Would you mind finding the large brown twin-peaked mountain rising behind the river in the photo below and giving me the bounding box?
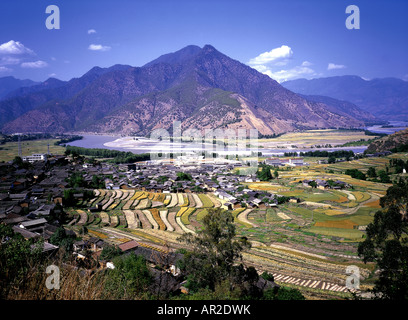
[0,45,363,135]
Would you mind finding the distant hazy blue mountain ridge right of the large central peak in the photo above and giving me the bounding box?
[282,76,408,120]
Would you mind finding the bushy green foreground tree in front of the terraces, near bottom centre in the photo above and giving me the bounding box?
[179,208,253,292]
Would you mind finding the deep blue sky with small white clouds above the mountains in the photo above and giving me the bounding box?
[0,0,408,82]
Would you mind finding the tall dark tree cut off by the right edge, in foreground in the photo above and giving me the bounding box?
[358,180,408,300]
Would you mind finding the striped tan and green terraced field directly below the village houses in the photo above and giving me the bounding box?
[73,189,221,233]
